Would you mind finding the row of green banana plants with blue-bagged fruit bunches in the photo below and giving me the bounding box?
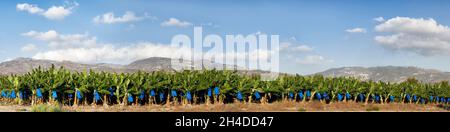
[0,66,450,106]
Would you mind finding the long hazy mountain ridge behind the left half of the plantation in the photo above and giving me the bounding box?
[0,57,245,75]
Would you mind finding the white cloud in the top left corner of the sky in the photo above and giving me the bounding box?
[16,2,79,20]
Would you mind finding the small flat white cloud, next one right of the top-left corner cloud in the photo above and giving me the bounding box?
[93,11,156,24]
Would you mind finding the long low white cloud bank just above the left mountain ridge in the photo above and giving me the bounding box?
[33,42,270,64]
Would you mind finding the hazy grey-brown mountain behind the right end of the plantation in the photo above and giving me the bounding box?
[316,66,450,82]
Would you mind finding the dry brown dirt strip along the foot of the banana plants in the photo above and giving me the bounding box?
[0,102,450,112]
